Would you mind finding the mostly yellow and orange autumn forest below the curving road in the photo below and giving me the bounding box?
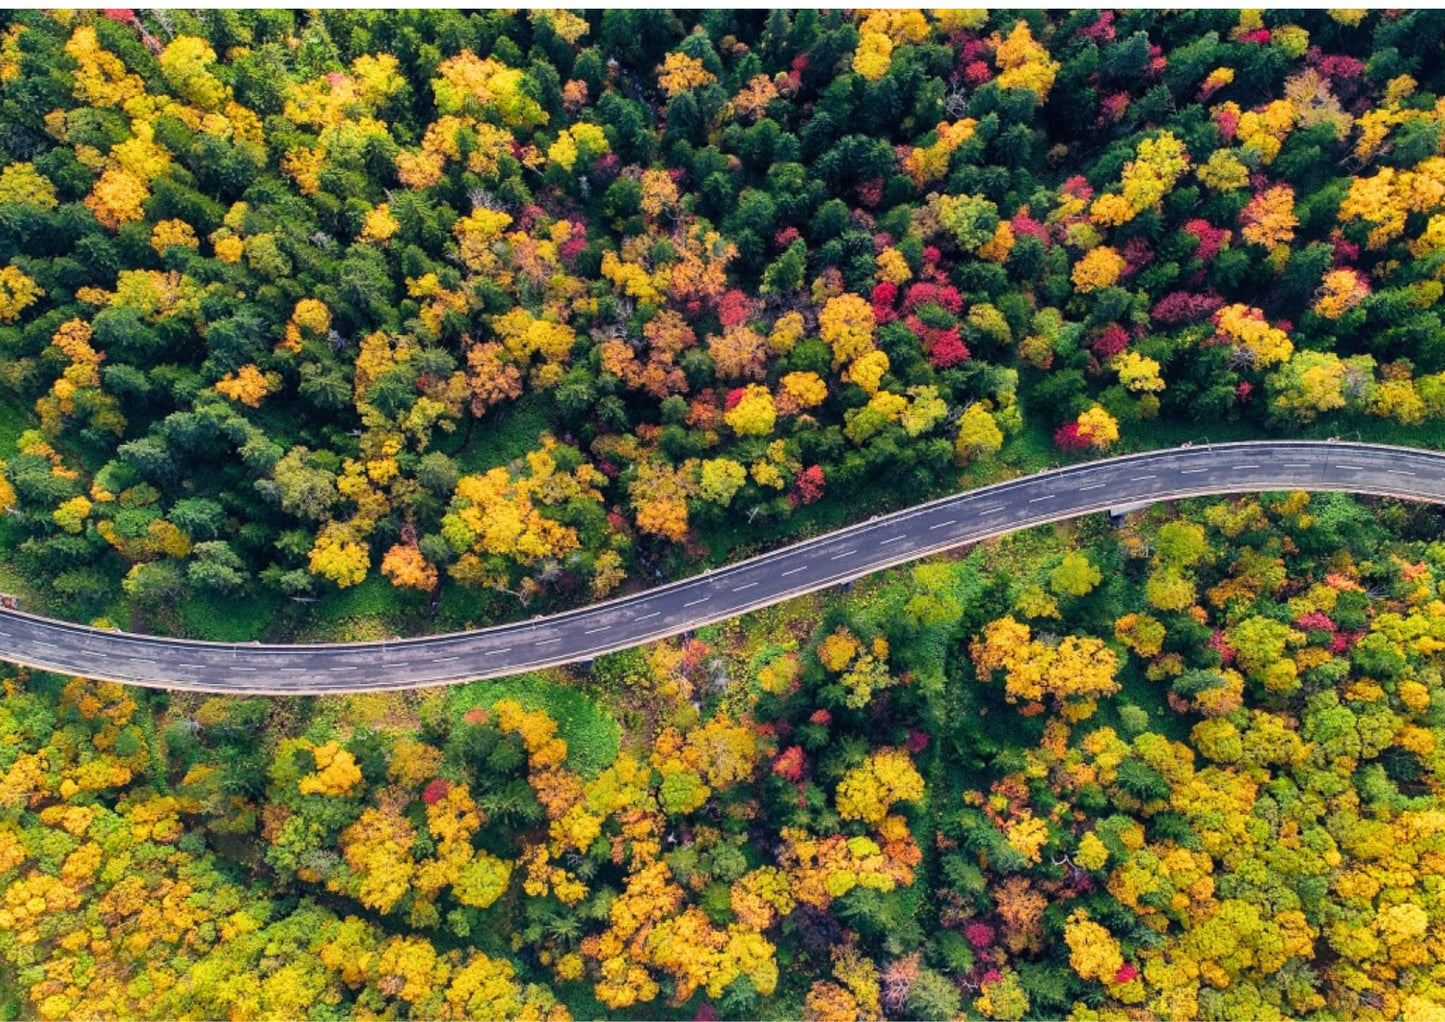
[0,493,1445,1019]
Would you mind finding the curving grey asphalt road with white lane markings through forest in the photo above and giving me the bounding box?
[0,441,1445,695]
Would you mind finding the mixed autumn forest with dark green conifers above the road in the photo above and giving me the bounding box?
[8,10,1445,637]
